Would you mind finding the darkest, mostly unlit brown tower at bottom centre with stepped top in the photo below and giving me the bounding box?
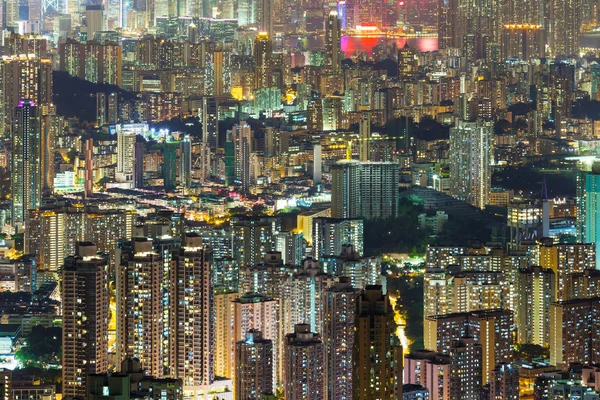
[352,285,403,400]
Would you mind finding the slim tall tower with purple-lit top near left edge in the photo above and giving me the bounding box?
[11,99,43,227]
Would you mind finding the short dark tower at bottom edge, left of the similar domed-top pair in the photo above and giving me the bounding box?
[234,330,274,400]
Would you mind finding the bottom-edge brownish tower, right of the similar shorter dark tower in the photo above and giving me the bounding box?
[283,324,325,400]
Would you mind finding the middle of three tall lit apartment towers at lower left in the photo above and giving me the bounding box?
[116,238,168,378]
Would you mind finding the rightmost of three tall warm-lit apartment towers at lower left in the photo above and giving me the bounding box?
[169,234,215,393]
